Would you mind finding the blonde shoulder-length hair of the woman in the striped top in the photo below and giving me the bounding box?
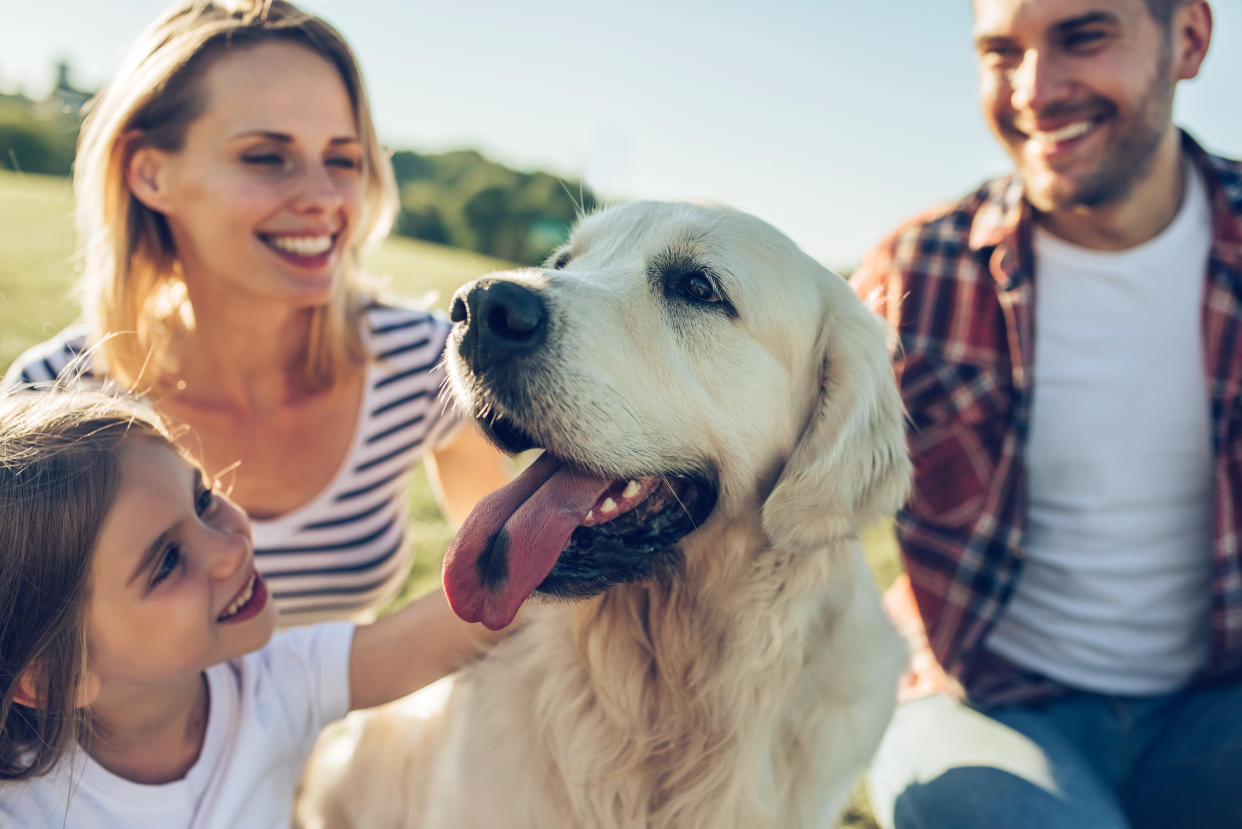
[73,0,396,389]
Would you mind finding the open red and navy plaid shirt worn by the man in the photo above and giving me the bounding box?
[853,135,1242,705]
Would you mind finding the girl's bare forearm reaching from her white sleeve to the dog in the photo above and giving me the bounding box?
[349,590,513,710]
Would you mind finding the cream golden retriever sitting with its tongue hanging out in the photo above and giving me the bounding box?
[299,203,909,829]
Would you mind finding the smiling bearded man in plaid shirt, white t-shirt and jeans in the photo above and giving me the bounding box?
[854,0,1242,829]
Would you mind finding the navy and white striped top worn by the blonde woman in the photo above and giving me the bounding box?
[6,306,460,625]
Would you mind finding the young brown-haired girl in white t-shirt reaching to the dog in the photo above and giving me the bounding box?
[0,393,504,829]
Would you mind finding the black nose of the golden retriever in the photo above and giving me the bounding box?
[448,280,548,372]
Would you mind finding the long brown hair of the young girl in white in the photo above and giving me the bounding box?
[0,392,175,779]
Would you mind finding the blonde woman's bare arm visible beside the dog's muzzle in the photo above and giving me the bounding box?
[426,423,513,527]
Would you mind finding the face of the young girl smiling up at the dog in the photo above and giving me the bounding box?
[87,437,276,689]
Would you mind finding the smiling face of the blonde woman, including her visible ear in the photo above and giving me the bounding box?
[138,41,366,311]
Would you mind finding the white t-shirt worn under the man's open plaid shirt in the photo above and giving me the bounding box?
[986,161,1213,695]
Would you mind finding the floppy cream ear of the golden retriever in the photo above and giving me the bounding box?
[763,285,910,549]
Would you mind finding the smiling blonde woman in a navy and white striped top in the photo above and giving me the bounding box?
[9,0,508,625]
